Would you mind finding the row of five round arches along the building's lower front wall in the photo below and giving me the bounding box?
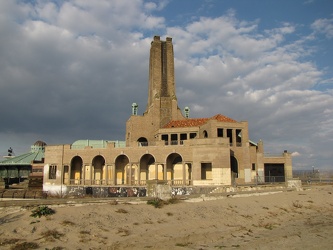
[63,153,192,186]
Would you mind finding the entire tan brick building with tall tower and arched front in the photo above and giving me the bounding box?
[43,36,292,196]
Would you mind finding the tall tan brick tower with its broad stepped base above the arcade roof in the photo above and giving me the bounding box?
[126,36,185,145]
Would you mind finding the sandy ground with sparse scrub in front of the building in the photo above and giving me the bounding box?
[0,185,333,250]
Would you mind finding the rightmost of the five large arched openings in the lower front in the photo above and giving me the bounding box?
[166,153,184,185]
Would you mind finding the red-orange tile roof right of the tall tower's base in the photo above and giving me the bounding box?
[164,114,237,128]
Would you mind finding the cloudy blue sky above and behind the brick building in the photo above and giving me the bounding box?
[0,0,333,169]
